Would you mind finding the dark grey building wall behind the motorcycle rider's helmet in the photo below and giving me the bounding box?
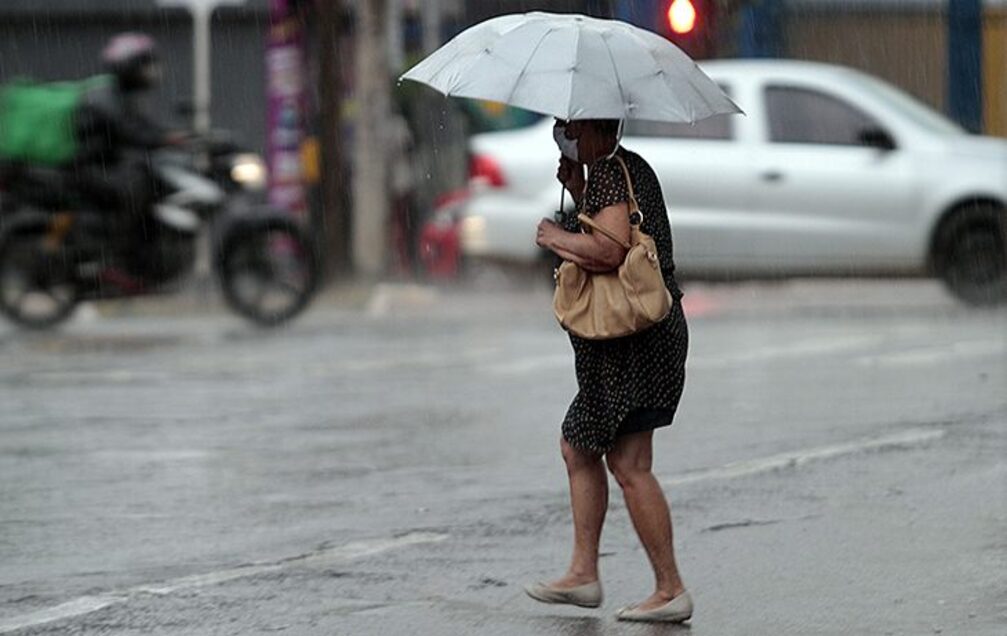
[0,0,268,151]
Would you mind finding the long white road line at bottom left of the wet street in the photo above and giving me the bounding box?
[0,532,448,634]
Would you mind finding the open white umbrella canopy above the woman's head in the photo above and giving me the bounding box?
[401,12,741,123]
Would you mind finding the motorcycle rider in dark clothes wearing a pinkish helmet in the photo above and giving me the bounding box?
[73,33,185,267]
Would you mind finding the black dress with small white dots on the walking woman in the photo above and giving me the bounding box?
[563,147,689,454]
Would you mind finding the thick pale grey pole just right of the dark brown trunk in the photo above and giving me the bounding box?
[352,0,391,278]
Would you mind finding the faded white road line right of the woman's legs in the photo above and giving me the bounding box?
[661,429,947,486]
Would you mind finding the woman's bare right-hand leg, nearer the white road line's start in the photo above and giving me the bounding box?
[605,431,685,610]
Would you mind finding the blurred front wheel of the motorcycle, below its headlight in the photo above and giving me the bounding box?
[219,220,319,327]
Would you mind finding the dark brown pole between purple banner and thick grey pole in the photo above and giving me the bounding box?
[316,0,352,276]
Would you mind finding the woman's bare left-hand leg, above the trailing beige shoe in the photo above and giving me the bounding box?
[549,440,608,590]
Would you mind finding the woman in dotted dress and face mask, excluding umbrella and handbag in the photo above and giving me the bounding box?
[526,119,693,623]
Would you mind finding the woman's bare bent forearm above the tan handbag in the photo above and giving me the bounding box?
[536,203,629,272]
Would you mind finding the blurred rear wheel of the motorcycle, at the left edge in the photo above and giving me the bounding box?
[0,228,80,329]
